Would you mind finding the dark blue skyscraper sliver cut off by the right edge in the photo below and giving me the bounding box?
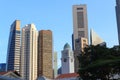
[115,0,120,45]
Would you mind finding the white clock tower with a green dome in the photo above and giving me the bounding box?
[61,43,74,74]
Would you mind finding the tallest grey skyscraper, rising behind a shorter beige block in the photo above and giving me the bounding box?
[73,4,88,50]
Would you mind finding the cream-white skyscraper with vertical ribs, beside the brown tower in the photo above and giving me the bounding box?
[20,24,38,80]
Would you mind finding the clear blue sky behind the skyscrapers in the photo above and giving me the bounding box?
[0,0,118,66]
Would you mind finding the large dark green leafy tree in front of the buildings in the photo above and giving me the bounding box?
[78,45,120,80]
